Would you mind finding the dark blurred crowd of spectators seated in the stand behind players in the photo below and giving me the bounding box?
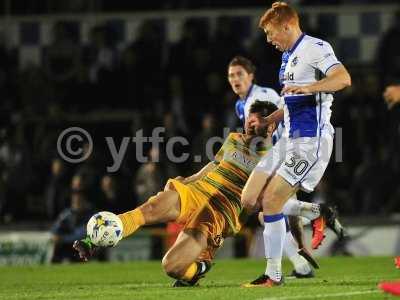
[0,10,400,223]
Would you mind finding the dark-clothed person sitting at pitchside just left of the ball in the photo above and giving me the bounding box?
[51,190,93,263]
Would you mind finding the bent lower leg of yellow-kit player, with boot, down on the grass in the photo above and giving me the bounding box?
[162,229,211,287]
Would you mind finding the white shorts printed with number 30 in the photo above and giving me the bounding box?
[254,126,333,192]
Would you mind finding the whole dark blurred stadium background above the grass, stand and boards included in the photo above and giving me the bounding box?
[0,0,400,262]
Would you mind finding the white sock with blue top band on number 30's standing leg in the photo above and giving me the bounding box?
[263,213,286,281]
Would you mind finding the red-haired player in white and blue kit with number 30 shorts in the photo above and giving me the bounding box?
[242,2,351,287]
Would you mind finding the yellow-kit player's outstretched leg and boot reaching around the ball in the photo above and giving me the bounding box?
[73,190,180,261]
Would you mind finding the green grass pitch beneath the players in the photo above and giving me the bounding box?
[0,257,400,300]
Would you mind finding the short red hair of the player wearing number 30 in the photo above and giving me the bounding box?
[258,2,299,28]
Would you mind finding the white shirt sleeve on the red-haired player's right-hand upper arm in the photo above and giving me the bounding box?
[307,41,341,74]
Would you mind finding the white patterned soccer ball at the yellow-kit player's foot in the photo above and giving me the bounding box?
[86,211,123,247]
